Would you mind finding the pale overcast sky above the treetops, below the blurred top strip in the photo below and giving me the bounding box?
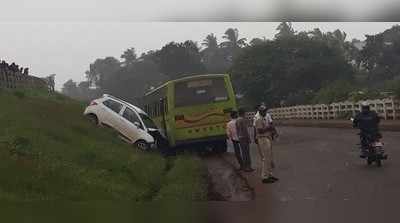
[0,22,395,89]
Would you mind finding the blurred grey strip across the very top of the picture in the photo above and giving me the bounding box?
[0,0,399,22]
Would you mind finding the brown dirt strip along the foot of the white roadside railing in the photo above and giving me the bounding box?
[275,119,400,132]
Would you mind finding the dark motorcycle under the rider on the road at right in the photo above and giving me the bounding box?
[351,119,388,167]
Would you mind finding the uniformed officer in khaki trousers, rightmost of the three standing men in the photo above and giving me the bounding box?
[254,105,279,183]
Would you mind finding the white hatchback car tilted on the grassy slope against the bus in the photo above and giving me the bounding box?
[84,94,158,150]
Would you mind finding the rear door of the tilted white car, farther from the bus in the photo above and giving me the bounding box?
[103,99,123,129]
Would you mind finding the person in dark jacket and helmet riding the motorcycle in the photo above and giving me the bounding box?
[353,102,381,158]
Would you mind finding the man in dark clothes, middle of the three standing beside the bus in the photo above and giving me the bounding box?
[236,109,254,172]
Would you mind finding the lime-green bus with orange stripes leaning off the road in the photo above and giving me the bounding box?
[143,74,237,152]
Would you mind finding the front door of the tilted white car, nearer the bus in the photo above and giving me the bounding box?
[122,107,147,142]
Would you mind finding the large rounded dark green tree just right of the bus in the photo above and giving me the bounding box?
[231,33,354,106]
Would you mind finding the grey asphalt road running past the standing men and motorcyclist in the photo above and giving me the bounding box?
[209,127,400,223]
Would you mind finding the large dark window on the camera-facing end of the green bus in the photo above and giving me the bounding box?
[175,78,229,107]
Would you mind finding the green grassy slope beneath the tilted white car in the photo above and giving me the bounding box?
[0,89,206,201]
